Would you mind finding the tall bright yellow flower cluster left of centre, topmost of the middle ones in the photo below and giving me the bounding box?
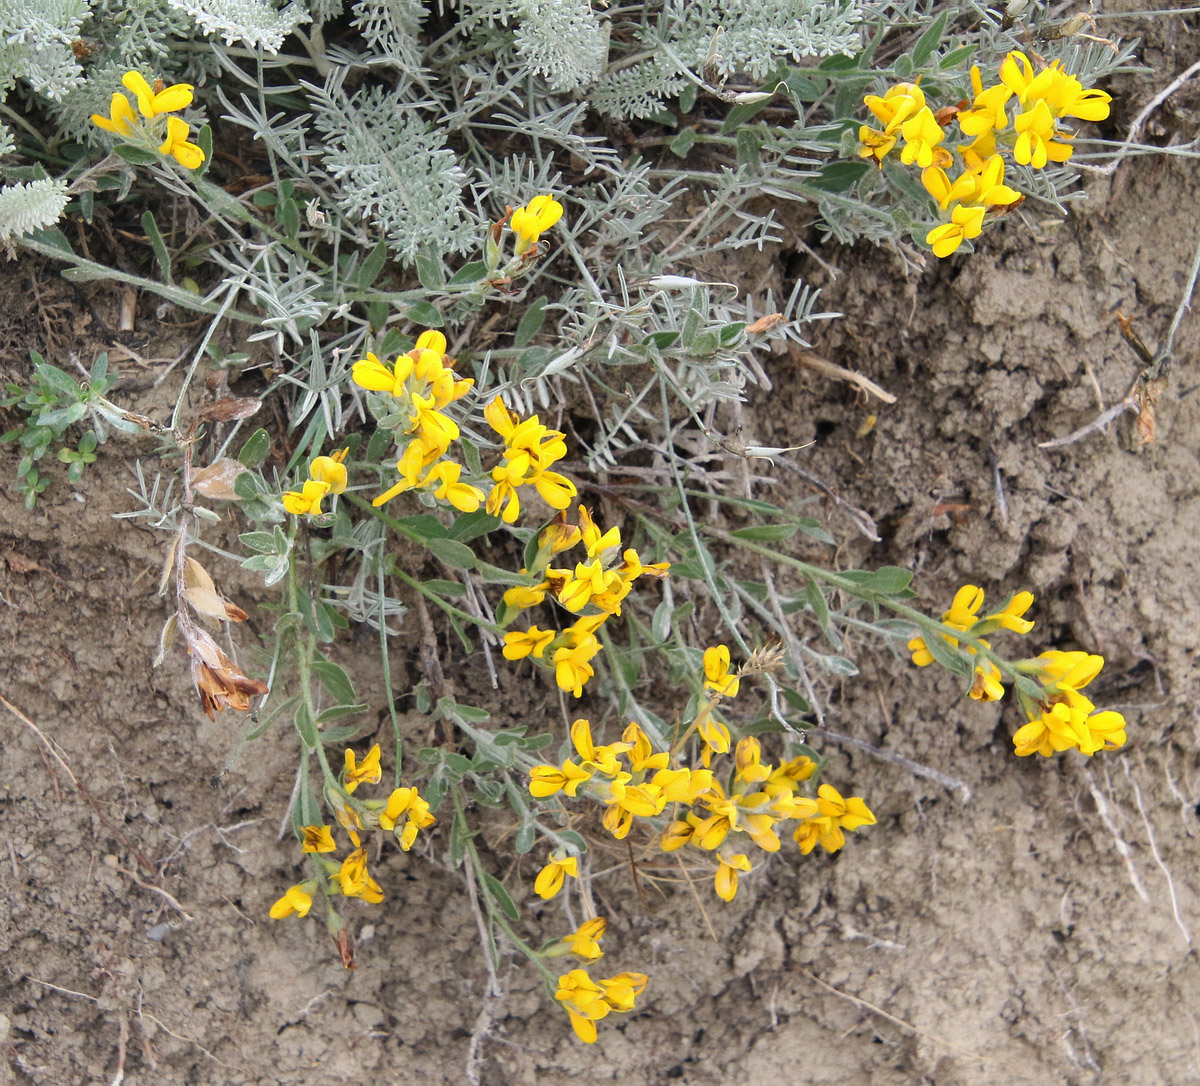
[350,331,484,512]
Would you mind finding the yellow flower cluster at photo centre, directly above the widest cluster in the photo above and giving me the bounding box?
[493,506,670,697]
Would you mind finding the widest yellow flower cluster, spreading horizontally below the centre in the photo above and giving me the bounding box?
[529,686,875,901]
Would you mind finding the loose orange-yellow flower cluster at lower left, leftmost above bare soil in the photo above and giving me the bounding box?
[271,743,437,920]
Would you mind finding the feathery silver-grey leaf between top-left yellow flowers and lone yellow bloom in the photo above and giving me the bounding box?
[305,68,481,263]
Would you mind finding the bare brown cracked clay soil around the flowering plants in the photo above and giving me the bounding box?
[0,16,1200,1086]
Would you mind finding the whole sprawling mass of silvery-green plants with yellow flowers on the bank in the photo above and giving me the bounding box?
[0,0,1161,1042]
